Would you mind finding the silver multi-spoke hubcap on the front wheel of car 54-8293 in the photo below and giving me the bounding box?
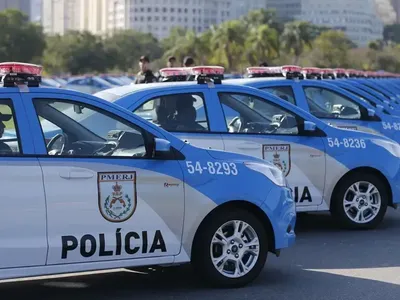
[210,220,260,278]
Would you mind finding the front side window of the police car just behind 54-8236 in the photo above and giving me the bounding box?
[303,86,362,120]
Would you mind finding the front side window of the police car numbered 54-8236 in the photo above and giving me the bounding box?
[218,93,299,135]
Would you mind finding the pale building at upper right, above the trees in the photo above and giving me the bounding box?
[267,0,383,46]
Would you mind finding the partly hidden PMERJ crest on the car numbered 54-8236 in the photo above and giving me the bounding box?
[263,144,291,177]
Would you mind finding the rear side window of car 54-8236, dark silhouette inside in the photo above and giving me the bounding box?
[133,93,209,132]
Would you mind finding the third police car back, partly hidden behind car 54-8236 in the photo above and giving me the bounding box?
[229,66,400,142]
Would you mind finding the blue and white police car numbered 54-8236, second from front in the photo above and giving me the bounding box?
[94,66,400,228]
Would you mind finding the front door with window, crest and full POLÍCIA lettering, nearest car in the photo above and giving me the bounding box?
[23,93,184,265]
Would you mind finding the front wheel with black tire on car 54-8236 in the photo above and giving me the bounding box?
[331,172,389,229]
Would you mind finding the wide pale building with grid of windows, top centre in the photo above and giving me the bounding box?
[108,0,266,39]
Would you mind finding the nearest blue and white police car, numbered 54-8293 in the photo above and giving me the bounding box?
[0,63,296,287]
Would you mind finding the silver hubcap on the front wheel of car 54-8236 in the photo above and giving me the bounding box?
[343,181,381,224]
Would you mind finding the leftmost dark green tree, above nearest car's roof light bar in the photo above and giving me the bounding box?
[0,9,46,62]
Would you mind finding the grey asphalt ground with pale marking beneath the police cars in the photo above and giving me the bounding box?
[0,209,400,300]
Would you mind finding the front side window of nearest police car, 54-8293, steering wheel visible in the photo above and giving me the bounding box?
[34,99,151,158]
